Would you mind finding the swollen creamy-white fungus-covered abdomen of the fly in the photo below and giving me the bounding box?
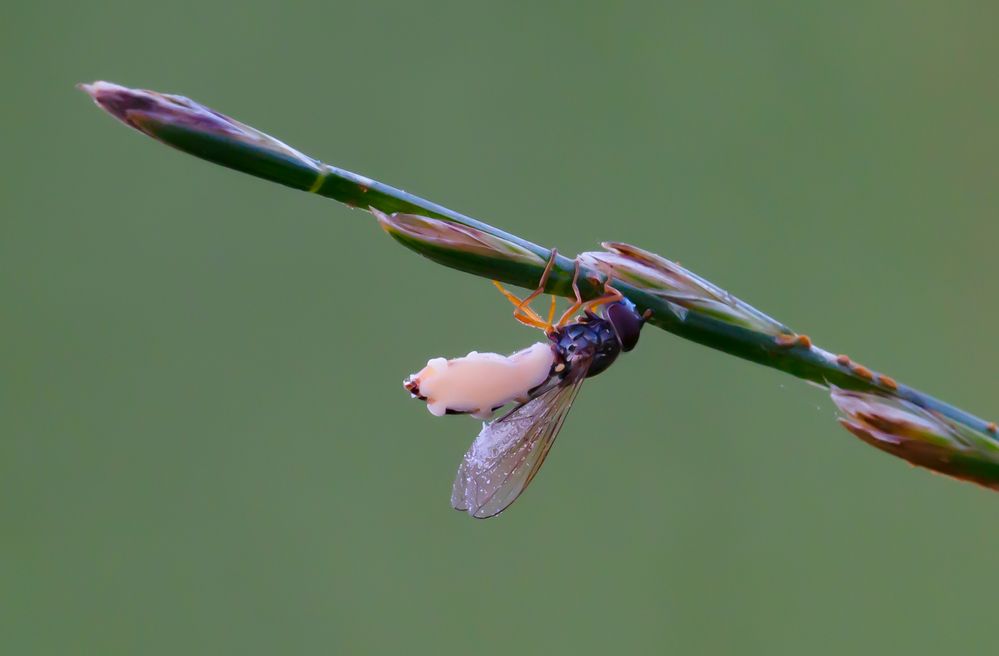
[405,342,555,419]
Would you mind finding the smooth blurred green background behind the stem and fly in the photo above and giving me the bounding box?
[0,0,999,655]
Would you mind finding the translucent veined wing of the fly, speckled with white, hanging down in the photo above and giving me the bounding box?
[451,363,589,519]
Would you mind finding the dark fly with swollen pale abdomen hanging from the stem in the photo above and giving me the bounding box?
[404,250,648,519]
